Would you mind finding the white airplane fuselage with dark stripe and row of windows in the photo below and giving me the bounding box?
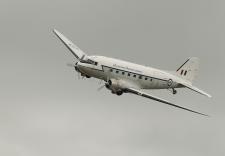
[77,56,180,89]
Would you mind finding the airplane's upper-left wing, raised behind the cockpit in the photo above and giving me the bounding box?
[53,29,86,60]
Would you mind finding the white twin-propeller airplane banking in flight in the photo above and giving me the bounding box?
[53,29,211,116]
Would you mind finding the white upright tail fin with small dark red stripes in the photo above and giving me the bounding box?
[176,57,199,83]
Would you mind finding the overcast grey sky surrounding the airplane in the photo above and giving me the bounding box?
[0,0,225,156]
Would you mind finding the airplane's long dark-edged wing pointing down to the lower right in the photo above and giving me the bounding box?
[125,88,208,116]
